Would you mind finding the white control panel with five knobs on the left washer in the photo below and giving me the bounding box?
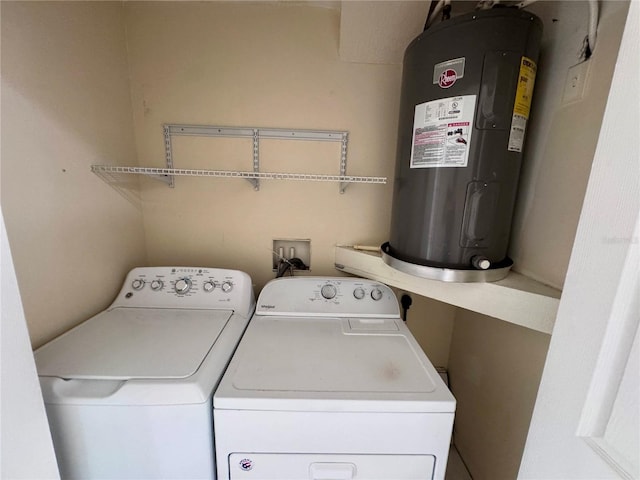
[110,267,254,316]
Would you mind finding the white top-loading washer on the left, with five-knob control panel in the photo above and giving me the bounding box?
[35,267,255,479]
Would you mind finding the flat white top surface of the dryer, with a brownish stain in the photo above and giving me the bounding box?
[229,316,436,398]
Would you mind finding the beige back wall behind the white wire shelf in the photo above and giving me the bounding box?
[125,2,401,290]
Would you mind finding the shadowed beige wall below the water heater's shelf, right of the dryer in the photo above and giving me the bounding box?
[449,309,550,480]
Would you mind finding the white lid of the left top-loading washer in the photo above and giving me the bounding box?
[35,307,233,380]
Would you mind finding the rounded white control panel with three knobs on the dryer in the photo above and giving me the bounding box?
[256,277,400,318]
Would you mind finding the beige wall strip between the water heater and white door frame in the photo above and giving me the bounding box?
[509,0,628,289]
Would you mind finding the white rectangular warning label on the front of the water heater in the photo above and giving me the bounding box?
[410,95,476,168]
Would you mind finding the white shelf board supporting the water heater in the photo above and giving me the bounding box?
[335,247,562,334]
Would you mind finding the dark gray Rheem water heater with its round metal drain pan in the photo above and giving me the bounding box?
[382,8,542,281]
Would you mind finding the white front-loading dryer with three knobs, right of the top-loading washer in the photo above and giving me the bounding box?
[213,277,456,480]
